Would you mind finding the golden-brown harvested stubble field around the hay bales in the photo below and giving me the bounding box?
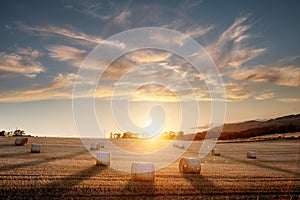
[0,137,300,199]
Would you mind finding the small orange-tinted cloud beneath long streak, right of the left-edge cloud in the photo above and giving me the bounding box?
[46,45,86,67]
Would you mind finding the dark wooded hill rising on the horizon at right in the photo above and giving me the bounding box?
[194,114,300,140]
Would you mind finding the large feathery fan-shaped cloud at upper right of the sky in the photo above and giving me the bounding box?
[207,16,266,69]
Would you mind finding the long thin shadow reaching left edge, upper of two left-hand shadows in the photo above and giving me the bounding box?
[1,150,87,171]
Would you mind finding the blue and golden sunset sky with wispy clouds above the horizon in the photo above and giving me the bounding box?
[0,0,300,137]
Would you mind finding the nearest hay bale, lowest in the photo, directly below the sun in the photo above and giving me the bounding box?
[131,162,155,182]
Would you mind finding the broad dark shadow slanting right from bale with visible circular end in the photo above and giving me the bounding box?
[181,174,224,195]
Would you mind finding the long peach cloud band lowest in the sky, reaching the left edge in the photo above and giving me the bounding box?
[0,73,76,102]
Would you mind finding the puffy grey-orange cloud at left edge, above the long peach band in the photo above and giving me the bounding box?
[0,48,45,78]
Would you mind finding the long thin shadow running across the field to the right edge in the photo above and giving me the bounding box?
[222,155,300,176]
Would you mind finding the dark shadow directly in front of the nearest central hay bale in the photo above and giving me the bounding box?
[122,180,155,199]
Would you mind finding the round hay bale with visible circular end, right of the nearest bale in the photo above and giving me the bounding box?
[178,158,201,174]
